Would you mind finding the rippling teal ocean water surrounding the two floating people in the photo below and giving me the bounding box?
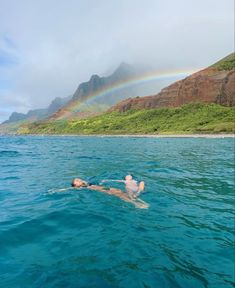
[0,136,235,288]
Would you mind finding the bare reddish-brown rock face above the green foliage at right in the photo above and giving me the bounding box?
[109,68,235,112]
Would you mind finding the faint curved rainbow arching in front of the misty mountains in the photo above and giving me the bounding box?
[69,69,198,112]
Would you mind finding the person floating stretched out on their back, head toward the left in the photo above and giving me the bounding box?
[71,178,149,208]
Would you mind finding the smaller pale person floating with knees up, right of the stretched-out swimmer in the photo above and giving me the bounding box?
[101,175,145,199]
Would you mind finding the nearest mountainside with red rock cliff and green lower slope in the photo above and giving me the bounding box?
[5,53,235,134]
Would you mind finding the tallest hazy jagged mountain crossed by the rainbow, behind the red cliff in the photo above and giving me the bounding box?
[50,62,184,120]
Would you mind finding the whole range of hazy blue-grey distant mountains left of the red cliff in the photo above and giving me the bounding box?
[2,62,180,124]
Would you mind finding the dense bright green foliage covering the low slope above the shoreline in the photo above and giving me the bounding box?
[19,103,235,134]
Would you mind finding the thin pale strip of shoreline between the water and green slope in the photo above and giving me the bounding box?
[0,134,235,138]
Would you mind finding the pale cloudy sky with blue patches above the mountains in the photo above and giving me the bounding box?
[0,0,234,122]
